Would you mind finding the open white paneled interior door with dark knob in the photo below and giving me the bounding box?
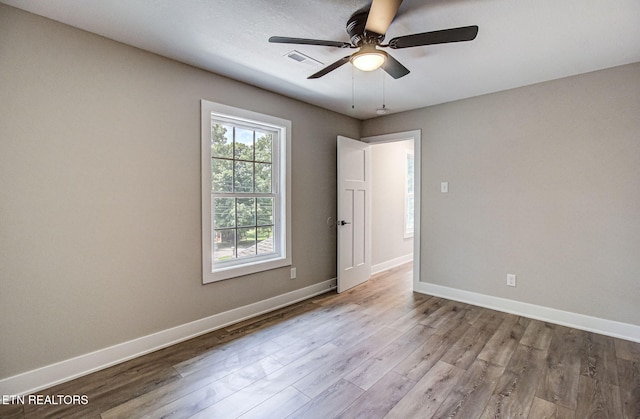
[338,136,371,293]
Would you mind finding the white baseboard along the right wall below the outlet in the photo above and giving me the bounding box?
[414,282,640,342]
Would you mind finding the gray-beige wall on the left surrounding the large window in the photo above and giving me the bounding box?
[0,5,360,378]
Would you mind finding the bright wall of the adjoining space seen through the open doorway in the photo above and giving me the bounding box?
[371,140,413,265]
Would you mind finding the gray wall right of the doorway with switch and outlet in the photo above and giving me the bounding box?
[362,64,640,325]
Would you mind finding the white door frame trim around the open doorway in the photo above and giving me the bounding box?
[360,129,422,291]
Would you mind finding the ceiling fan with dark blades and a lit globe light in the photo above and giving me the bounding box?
[269,0,478,79]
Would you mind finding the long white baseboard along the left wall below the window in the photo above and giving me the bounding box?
[0,278,336,395]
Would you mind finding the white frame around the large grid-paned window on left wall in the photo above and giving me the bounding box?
[201,99,291,284]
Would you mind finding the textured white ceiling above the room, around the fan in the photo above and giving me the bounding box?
[5,0,640,119]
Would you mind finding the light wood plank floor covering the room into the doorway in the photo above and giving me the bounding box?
[0,264,640,419]
